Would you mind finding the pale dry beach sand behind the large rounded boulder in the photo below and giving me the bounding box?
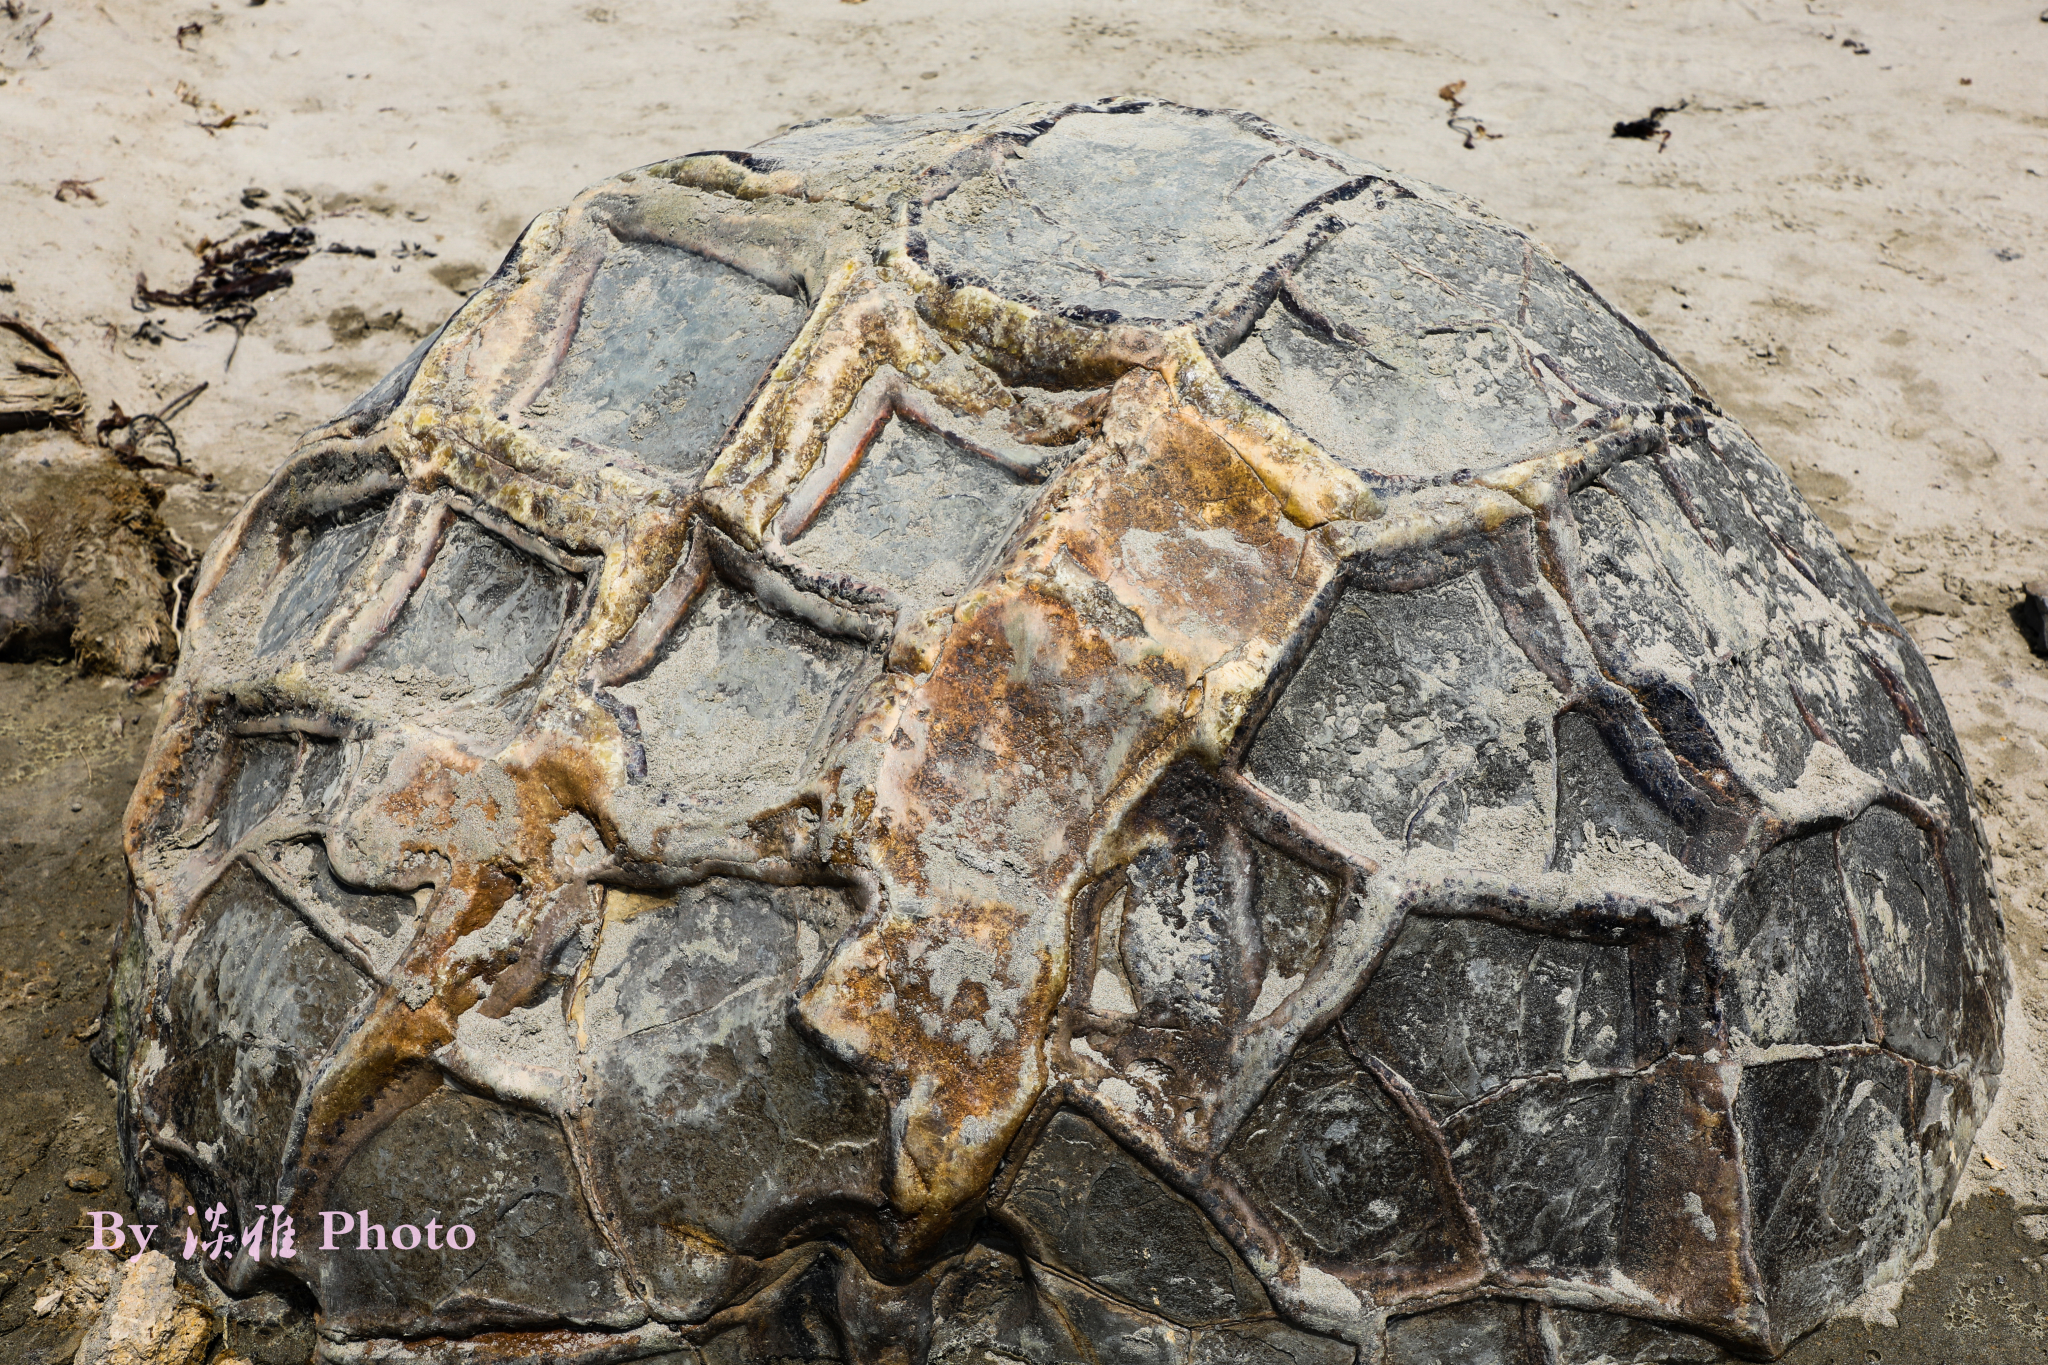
[0,0,2048,1361]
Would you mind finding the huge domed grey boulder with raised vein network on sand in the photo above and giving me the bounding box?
[98,100,2009,1363]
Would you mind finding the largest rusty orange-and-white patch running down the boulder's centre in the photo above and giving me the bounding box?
[799,362,1333,1242]
